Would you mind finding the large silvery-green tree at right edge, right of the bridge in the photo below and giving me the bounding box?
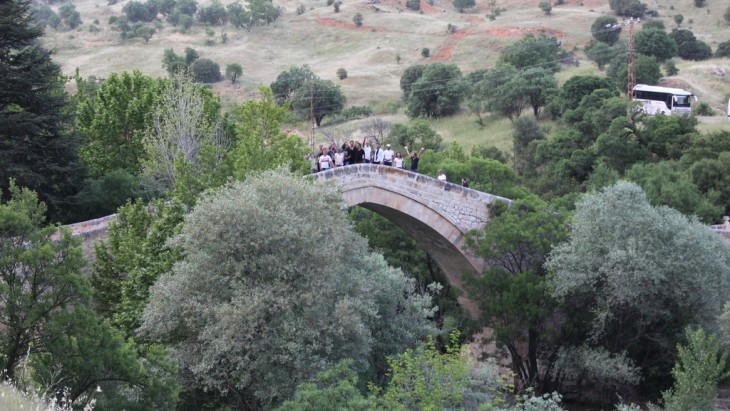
[547,182,730,392]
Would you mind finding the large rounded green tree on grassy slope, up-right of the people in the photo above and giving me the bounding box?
[408,63,465,118]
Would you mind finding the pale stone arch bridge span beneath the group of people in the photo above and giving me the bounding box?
[314,164,511,313]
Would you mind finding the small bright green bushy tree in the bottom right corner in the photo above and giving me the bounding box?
[663,327,729,411]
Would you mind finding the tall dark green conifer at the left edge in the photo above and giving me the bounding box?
[0,0,81,222]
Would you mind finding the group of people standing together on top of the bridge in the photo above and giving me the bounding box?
[309,138,425,173]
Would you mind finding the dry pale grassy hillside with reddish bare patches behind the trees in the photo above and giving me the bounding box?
[45,0,730,149]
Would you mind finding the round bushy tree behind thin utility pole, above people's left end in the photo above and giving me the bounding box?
[291,79,347,127]
